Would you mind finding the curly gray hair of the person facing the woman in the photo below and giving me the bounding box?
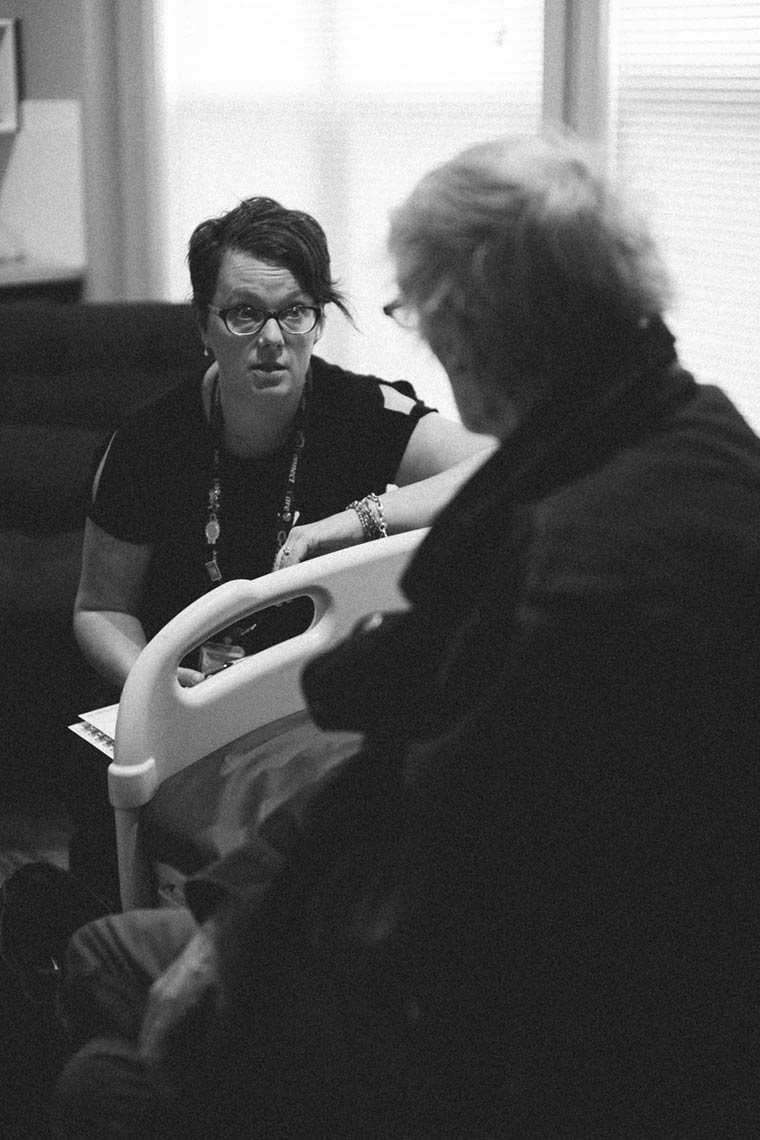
[389,132,669,408]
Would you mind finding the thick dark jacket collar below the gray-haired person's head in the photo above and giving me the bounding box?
[401,318,696,626]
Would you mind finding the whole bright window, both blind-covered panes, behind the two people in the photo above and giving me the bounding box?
[151,0,760,429]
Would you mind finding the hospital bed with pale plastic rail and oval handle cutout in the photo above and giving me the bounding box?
[108,530,426,909]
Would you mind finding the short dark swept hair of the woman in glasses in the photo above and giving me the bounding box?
[187,197,351,327]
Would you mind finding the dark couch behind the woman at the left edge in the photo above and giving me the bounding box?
[0,301,204,790]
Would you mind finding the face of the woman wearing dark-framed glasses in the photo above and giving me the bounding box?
[204,250,321,410]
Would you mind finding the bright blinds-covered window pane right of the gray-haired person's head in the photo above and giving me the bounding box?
[611,0,760,430]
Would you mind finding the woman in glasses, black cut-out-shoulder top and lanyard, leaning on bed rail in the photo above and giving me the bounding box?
[74,197,488,691]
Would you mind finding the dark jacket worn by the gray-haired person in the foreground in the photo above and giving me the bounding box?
[182,329,760,1140]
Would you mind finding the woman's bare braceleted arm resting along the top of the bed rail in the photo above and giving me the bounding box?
[277,386,498,569]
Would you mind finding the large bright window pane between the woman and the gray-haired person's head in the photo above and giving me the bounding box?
[158,0,544,414]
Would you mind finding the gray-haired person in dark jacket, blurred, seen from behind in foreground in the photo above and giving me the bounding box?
[52,138,760,1140]
